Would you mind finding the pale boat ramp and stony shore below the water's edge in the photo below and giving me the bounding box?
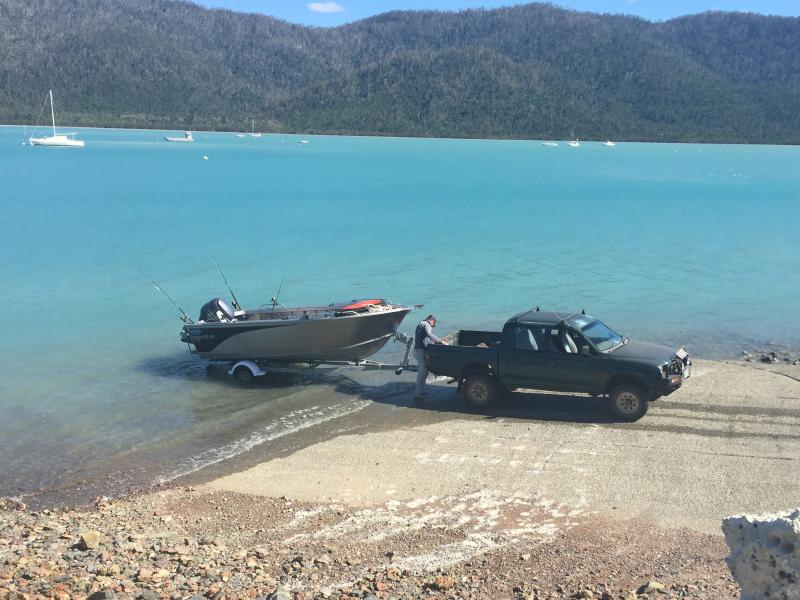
[0,361,800,599]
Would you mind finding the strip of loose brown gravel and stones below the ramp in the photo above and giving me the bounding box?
[0,488,737,600]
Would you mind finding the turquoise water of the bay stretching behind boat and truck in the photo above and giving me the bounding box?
[0,127,800,506]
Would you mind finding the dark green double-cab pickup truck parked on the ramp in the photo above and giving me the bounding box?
[426,307,691,421]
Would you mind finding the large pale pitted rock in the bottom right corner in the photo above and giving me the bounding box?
[722,509,800,600]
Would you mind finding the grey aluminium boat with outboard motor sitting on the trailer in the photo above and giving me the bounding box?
[181,298,412,363]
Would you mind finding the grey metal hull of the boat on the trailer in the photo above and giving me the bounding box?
[183,307,411,362]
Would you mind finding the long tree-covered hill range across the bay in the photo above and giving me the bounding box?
[0,0,800,144]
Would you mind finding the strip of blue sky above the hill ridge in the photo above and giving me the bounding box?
[194,0,800,27]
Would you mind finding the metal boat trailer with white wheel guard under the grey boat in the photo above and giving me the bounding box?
[208,331,417,385]
